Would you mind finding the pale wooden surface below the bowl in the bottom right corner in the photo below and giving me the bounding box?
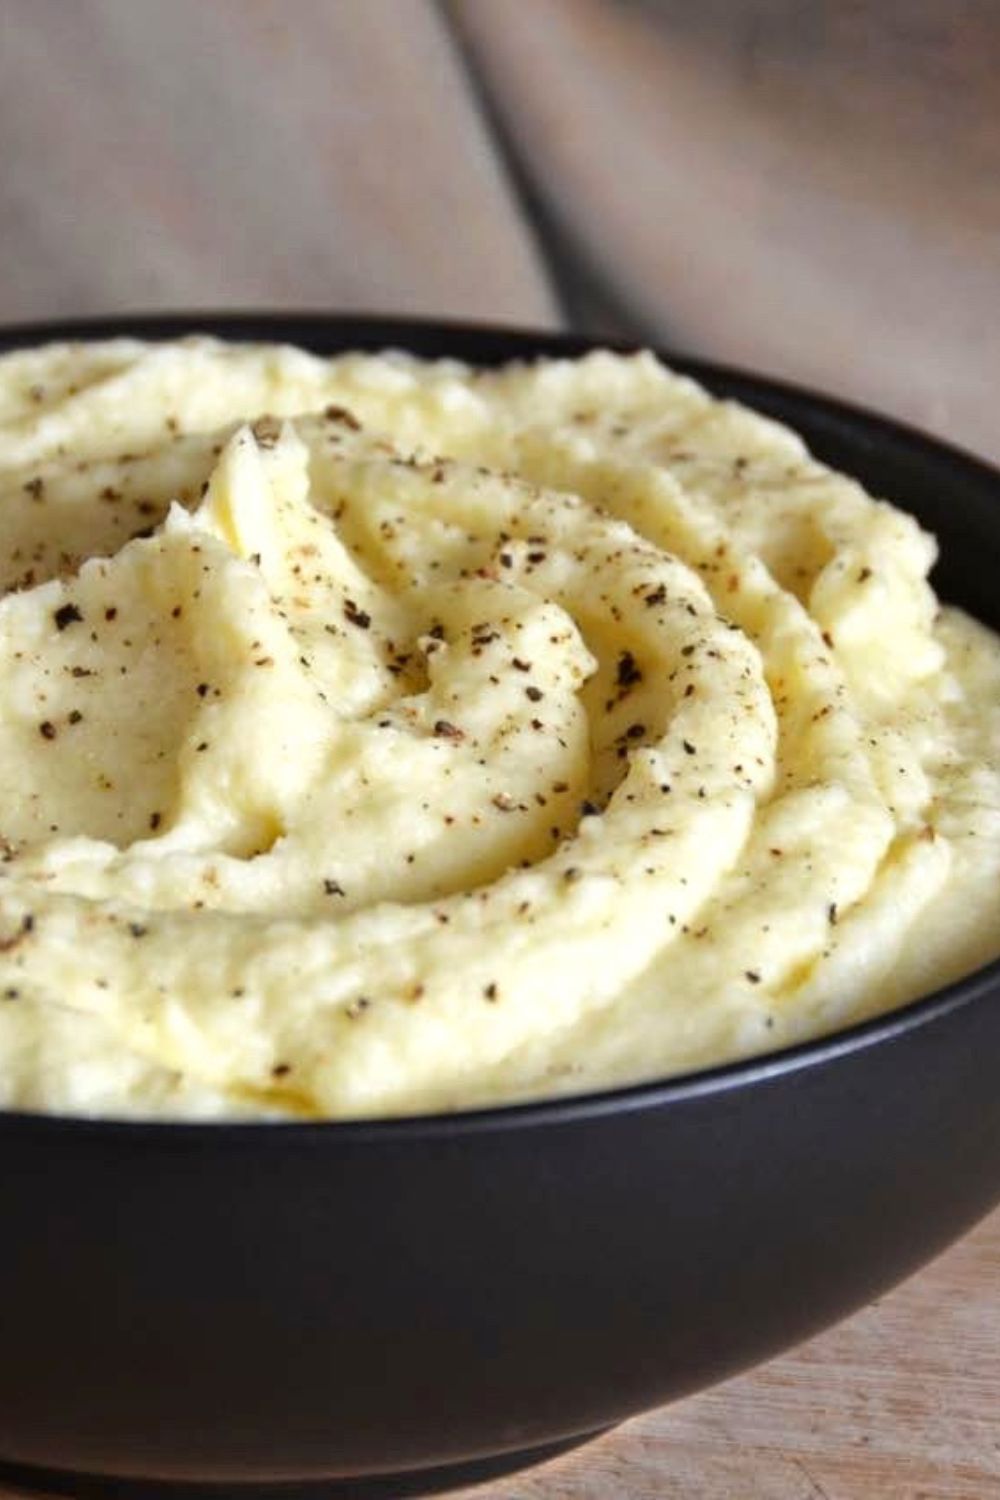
[456,1214,1000,1500]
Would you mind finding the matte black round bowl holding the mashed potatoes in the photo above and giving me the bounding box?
[0,317,1000,1497]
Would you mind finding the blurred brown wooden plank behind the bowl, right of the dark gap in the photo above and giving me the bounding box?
[451,0,1000,459]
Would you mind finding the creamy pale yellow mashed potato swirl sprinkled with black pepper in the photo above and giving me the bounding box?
[0,338,1000,1118]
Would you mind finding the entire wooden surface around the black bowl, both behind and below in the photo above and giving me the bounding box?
[0,0,1000,1500]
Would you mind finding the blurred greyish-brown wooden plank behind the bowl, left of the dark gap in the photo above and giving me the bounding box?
[0,0,555,323]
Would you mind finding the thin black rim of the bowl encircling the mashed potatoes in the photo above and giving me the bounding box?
[0,309,1000,1149]
